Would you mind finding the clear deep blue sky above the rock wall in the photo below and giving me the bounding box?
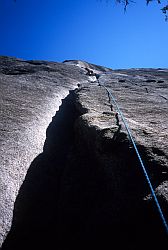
[0,0,168,69]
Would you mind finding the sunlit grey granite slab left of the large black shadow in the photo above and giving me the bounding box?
[0,57,87,243]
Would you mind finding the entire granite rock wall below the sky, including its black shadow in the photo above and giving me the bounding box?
[0,57,168,250]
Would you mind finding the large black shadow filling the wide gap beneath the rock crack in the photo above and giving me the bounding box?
[2,91,168,250]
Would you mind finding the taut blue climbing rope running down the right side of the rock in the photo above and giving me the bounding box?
[100,84,168,235]
